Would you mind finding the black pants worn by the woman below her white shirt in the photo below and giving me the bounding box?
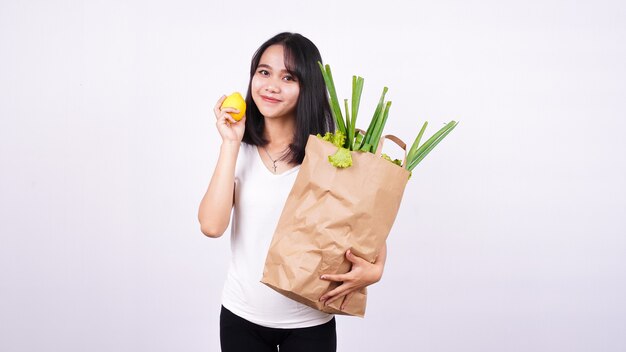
[220,306,337,352]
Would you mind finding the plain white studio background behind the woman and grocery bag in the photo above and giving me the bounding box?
[0,0,626,352]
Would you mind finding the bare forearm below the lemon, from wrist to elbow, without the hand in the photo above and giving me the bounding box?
[198,142,241,237]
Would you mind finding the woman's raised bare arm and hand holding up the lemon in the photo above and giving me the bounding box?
[198,96,246,238]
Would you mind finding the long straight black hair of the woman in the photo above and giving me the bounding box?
[243,32,335,164]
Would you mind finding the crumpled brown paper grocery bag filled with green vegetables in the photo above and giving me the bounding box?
[261,136,409,317]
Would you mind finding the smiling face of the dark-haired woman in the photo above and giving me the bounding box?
[251,44,300,118]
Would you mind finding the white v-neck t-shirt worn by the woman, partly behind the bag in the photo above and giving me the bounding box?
[222,143,333,329]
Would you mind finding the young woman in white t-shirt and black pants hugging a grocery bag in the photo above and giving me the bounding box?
[198,33,386,352]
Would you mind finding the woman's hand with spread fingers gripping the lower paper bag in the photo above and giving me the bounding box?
[320,250,385,310]
